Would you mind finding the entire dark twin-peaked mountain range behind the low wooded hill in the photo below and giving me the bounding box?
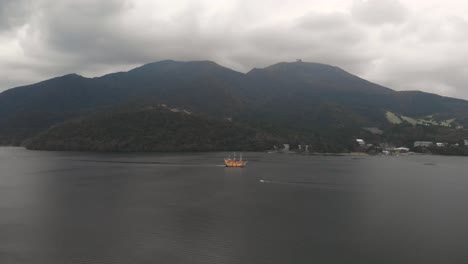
[0,60,468,151]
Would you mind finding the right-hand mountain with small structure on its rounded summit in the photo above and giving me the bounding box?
[246,62,468,122]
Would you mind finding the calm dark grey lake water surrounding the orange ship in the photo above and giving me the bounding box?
[0,148,468,264]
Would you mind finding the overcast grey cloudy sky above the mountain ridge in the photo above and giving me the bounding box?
[0,0,468,99]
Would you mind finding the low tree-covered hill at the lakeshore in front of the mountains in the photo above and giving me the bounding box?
[26,107,280,151]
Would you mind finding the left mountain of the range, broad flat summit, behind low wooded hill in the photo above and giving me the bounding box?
[0,61,247,141]
